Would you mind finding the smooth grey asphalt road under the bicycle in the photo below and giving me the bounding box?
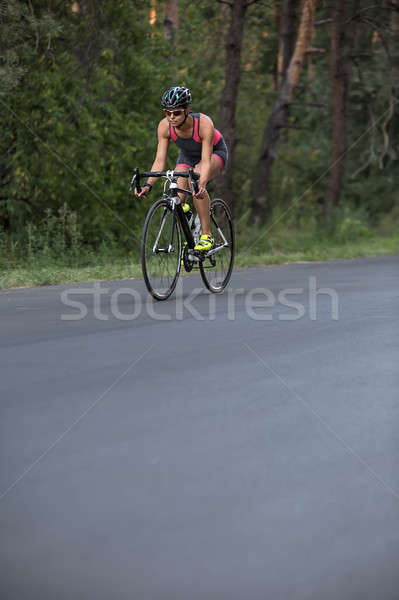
[0,257,399,600]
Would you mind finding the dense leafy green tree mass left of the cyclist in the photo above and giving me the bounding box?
[0,0,167,243]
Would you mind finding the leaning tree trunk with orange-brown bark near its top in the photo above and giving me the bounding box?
[250,0,317,226]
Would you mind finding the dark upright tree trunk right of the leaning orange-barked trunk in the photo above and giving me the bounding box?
[324,0,359,219]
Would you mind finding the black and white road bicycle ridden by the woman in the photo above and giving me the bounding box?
[130,168,234,300]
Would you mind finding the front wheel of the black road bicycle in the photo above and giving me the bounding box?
[141,200,181,300]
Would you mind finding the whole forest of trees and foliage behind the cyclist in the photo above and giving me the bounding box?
[0,0,399,284]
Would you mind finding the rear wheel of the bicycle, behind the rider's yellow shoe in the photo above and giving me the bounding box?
[199,198,235,294]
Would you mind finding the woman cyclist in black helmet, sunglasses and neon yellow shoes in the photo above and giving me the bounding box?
[135,86,228,251]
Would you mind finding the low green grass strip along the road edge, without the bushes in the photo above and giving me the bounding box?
[0,229,399,289]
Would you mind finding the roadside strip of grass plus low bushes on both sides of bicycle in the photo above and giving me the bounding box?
[0,206,399,289]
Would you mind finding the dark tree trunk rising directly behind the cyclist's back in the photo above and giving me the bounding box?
[215,0,248,212]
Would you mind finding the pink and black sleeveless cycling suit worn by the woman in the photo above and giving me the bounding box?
[169,113,228,169]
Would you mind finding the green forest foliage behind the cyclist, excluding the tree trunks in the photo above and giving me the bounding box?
[0,0,399,272]
